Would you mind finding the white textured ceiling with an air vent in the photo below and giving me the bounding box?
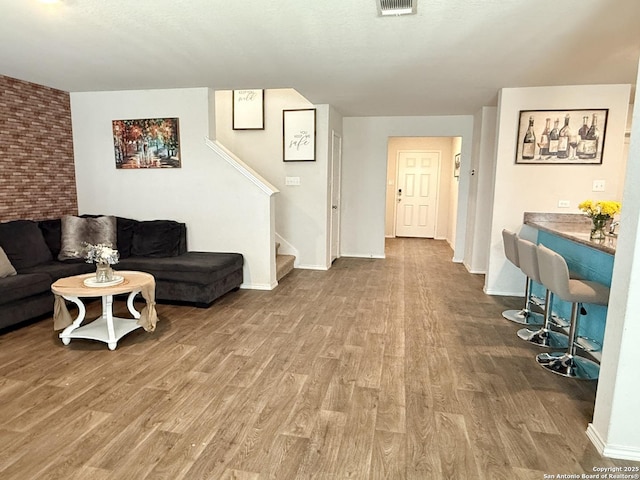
[0,0,640,116]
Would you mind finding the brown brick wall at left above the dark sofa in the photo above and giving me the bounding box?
[0,75,78,221]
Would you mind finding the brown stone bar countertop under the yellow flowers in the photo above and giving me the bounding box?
[523,212,618,255]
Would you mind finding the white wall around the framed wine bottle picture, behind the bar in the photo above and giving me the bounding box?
[485,85,630,295]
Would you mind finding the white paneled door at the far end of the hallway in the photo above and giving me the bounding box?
[396,151,440,238]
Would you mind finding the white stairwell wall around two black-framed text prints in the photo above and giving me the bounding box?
[215,88,340,269]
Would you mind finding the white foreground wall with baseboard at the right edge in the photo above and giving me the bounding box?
[587,61,640,461]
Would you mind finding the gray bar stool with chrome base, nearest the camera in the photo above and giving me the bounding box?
[536,245,609,380]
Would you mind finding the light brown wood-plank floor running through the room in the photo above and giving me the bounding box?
[0,239,639,480]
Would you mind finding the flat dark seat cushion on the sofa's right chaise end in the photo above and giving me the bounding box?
[114,252,244,285]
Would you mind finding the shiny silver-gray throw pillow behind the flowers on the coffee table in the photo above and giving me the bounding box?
[58,215,117,260]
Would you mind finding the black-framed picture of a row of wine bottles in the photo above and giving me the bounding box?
[516,108,609,165]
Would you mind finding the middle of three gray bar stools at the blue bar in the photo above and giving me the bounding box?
[518,238,573,348]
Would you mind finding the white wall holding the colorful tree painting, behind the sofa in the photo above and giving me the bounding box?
[71,88,273,289]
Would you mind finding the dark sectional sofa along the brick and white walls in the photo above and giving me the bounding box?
[0,215,244,329]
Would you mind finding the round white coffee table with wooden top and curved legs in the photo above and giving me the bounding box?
[51,271,156,350]
